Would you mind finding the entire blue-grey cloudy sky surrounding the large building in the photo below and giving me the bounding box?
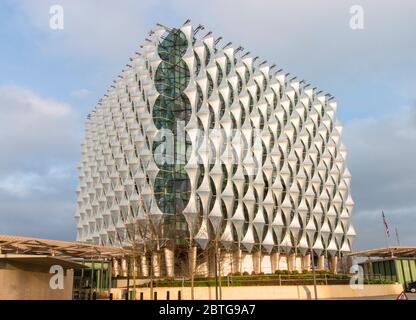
[0,0,416,249]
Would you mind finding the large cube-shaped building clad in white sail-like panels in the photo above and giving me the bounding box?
[75,23,355,276]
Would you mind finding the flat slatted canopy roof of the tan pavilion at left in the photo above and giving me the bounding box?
[0,235,130,259]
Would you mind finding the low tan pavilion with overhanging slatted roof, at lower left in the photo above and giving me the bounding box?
[0,235,127,300]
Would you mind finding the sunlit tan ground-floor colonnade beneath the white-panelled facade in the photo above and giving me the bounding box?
[109,252,339,278]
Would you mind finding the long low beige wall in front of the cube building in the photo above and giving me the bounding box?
[111,284,403,300]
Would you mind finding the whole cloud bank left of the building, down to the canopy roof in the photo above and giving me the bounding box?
[0,86,79,239]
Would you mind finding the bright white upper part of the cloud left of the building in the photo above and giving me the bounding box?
[0,86,83,170]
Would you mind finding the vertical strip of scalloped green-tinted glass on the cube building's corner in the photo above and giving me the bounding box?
[152,29,191,215]
